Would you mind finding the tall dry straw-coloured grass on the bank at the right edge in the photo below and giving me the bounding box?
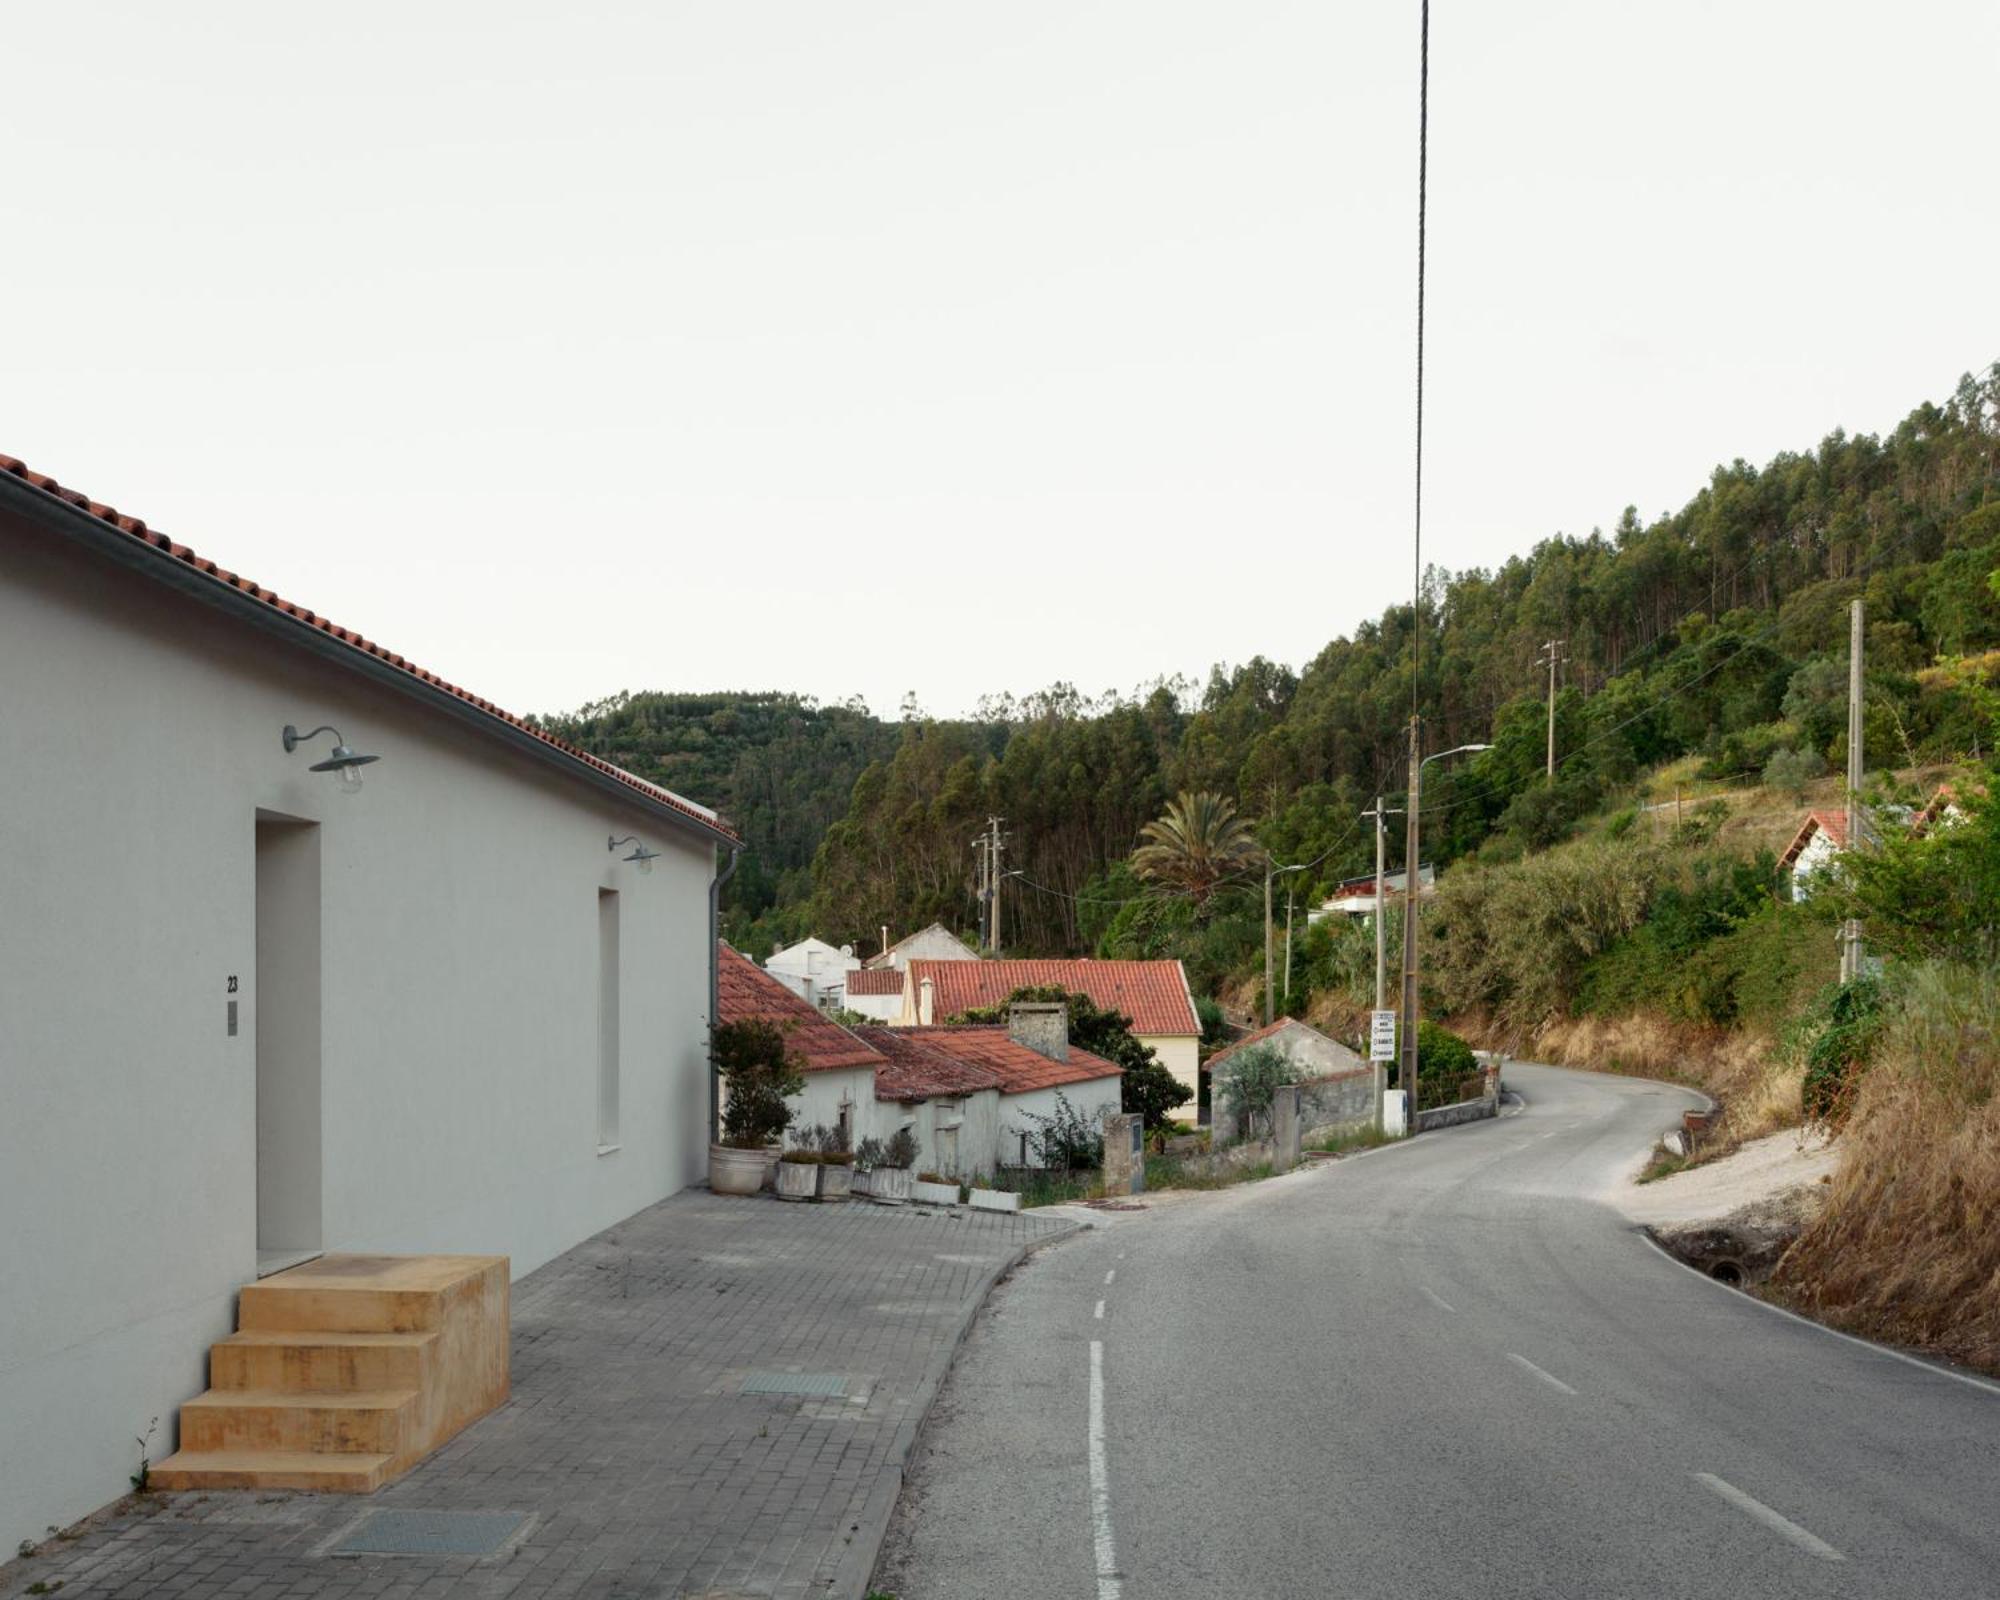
[1772,968,2000,1372]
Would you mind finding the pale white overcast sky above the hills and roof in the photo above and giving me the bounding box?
[0,0,2000,714]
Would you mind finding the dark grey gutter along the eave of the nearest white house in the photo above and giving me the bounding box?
[0,472,740,850]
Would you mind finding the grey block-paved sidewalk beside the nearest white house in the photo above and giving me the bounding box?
[0,1190,1076,1600]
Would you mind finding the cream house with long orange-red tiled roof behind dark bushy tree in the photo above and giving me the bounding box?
[896,960,1202,1122]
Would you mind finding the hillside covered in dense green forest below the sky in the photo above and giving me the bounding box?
[550,366,2000,968]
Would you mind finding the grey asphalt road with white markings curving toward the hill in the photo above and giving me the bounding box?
[876,1066,2000,1600]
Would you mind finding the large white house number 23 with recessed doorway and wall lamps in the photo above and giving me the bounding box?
[0,458,736,1550]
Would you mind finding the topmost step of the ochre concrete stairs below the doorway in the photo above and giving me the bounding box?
[236,1256,506,1334]
